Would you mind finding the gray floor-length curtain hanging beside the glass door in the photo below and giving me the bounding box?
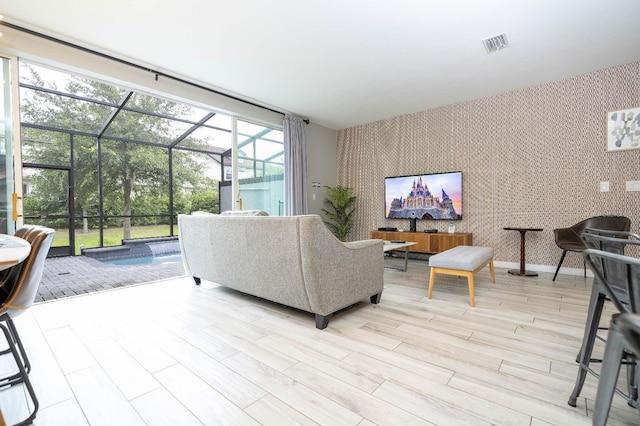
[282,115,307,216]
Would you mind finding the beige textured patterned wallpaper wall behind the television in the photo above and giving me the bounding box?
[338,63,640,268]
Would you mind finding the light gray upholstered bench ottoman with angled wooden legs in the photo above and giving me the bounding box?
[429,246,496,306]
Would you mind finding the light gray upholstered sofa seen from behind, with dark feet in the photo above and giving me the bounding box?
[178,213,383,329]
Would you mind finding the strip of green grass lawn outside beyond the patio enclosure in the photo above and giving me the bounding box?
[53,225,178,254]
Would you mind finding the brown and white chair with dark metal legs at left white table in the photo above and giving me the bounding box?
[0,226,54,425]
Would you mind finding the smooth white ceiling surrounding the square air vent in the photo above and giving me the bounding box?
[0,0,640,129]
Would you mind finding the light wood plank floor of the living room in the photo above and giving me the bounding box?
[0,260,639,426]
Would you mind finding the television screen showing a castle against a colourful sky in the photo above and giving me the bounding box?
[385,173,462,220]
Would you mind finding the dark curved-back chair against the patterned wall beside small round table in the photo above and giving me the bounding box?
[552,216,631,281]
